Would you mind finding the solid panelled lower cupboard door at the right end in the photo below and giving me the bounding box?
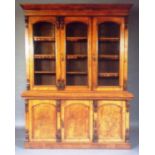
[96,101,126,142]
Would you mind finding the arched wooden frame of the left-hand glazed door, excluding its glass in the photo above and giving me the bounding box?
[26,16,61,90]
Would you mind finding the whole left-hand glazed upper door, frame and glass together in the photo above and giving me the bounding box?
[27,16,61,90]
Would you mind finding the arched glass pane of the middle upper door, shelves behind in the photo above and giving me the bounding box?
[66,22,88,86]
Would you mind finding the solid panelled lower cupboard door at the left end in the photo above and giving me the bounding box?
[29,100,57,141]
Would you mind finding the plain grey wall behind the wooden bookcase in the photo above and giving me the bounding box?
[15,0,139,127]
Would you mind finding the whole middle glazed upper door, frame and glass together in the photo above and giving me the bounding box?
[61,17,91,91]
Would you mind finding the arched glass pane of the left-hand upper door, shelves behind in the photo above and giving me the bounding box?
[33,22,56,85]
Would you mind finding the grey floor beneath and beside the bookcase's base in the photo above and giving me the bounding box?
[15,128,139,155]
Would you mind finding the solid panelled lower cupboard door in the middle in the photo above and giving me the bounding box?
[61,100,93,142]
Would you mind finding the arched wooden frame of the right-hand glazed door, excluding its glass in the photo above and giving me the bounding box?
[92,17,127,91]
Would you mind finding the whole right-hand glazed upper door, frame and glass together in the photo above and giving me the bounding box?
[92,17,125,90]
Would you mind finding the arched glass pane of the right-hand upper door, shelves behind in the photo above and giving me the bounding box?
[98,22,120,86]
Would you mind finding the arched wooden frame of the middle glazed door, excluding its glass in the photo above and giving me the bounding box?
[61,17,92,91]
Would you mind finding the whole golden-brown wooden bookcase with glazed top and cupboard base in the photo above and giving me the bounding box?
[21,4,133,148]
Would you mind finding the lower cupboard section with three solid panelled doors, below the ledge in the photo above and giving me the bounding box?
[25,100,129,148]
